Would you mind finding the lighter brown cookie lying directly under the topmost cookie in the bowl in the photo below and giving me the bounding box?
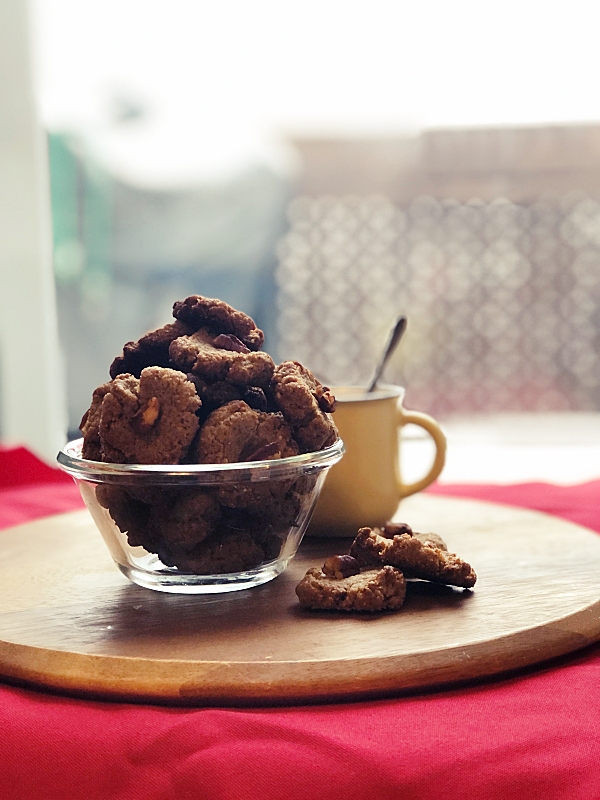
[169,328,275,387]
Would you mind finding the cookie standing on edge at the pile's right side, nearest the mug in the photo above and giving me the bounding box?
[271,361,337,453]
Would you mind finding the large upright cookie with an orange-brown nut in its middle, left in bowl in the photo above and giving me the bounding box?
[100,367,200,464]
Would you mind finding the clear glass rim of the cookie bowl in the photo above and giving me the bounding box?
[57,438,344,485]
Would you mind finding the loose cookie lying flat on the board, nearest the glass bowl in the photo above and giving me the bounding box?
[296,562,406,611]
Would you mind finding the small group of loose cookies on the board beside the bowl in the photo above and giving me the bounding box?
[296,522,477,611]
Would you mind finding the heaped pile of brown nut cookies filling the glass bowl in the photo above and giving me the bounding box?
[81,295,337,574]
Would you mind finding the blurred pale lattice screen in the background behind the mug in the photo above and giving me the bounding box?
[277,194,600,415]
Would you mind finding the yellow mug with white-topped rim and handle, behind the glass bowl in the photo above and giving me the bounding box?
[308,385,446,536]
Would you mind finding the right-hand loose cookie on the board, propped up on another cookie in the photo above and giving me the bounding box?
[350,528,477,589]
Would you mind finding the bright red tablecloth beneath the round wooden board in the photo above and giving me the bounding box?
[0,450,600,800]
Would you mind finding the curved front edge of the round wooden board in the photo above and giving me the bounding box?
[0,601,600,706]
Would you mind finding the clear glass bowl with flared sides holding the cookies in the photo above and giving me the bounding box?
[58,439,344,594]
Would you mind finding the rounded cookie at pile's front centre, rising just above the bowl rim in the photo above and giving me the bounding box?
[198,400,298,464]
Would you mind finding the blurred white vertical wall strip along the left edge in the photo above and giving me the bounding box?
[0,0,67,462]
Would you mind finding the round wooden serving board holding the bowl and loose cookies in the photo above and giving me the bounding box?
[0,494,600,705]
